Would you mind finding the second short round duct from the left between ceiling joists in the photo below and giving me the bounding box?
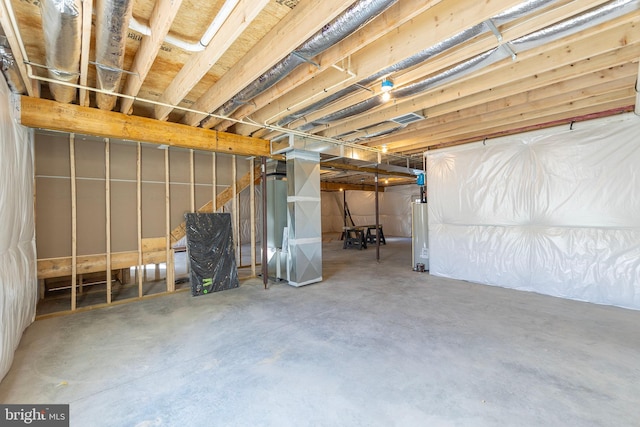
[96,0,133,110]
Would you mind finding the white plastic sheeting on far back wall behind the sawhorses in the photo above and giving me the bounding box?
[322,185,420,237]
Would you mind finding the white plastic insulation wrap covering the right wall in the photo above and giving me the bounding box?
[427,114,640,309]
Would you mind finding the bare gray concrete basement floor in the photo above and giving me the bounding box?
[0,238,640,426]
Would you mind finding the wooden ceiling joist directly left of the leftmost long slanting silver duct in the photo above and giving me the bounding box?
[182,0,353,126]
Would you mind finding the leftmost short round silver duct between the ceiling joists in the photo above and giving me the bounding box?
[40,0,82,103]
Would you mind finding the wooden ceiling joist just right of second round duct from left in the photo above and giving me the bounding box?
[120,0,182,114]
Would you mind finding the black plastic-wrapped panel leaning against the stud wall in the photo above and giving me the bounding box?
[184,213,239,296]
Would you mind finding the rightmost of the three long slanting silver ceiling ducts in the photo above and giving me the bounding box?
[297,0,640,132]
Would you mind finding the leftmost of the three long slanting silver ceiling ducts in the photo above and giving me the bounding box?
[208,0,397,122]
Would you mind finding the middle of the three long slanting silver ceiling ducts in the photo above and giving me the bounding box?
[278,0,557,129]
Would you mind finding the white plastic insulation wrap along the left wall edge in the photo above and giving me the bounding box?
[0,79,38,380]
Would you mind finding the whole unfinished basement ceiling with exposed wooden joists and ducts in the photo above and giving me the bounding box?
[1,0,640,182]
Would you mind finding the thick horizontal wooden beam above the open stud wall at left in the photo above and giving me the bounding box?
[20,96,270,156]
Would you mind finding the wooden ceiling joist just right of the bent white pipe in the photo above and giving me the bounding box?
[153,0,269,120]
